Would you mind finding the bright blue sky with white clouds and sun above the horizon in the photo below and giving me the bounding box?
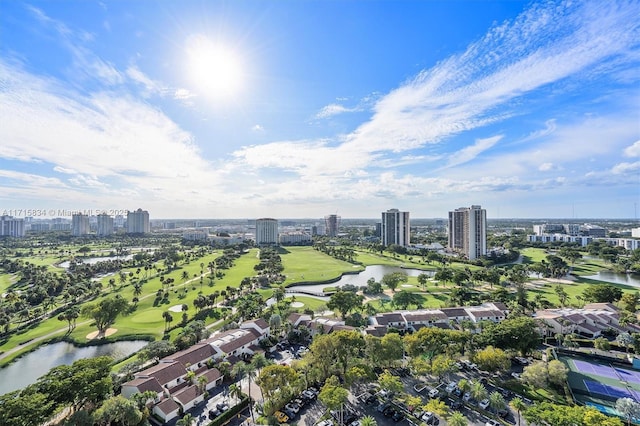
[0,0,640,219]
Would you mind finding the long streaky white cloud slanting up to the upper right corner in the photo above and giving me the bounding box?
[342,2,638,152]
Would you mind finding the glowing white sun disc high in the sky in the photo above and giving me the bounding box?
[187,36,244,98]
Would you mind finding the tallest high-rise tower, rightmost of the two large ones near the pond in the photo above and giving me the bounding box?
[449,206,487,260]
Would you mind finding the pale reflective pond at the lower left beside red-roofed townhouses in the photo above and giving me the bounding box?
[0,340,149,395]
